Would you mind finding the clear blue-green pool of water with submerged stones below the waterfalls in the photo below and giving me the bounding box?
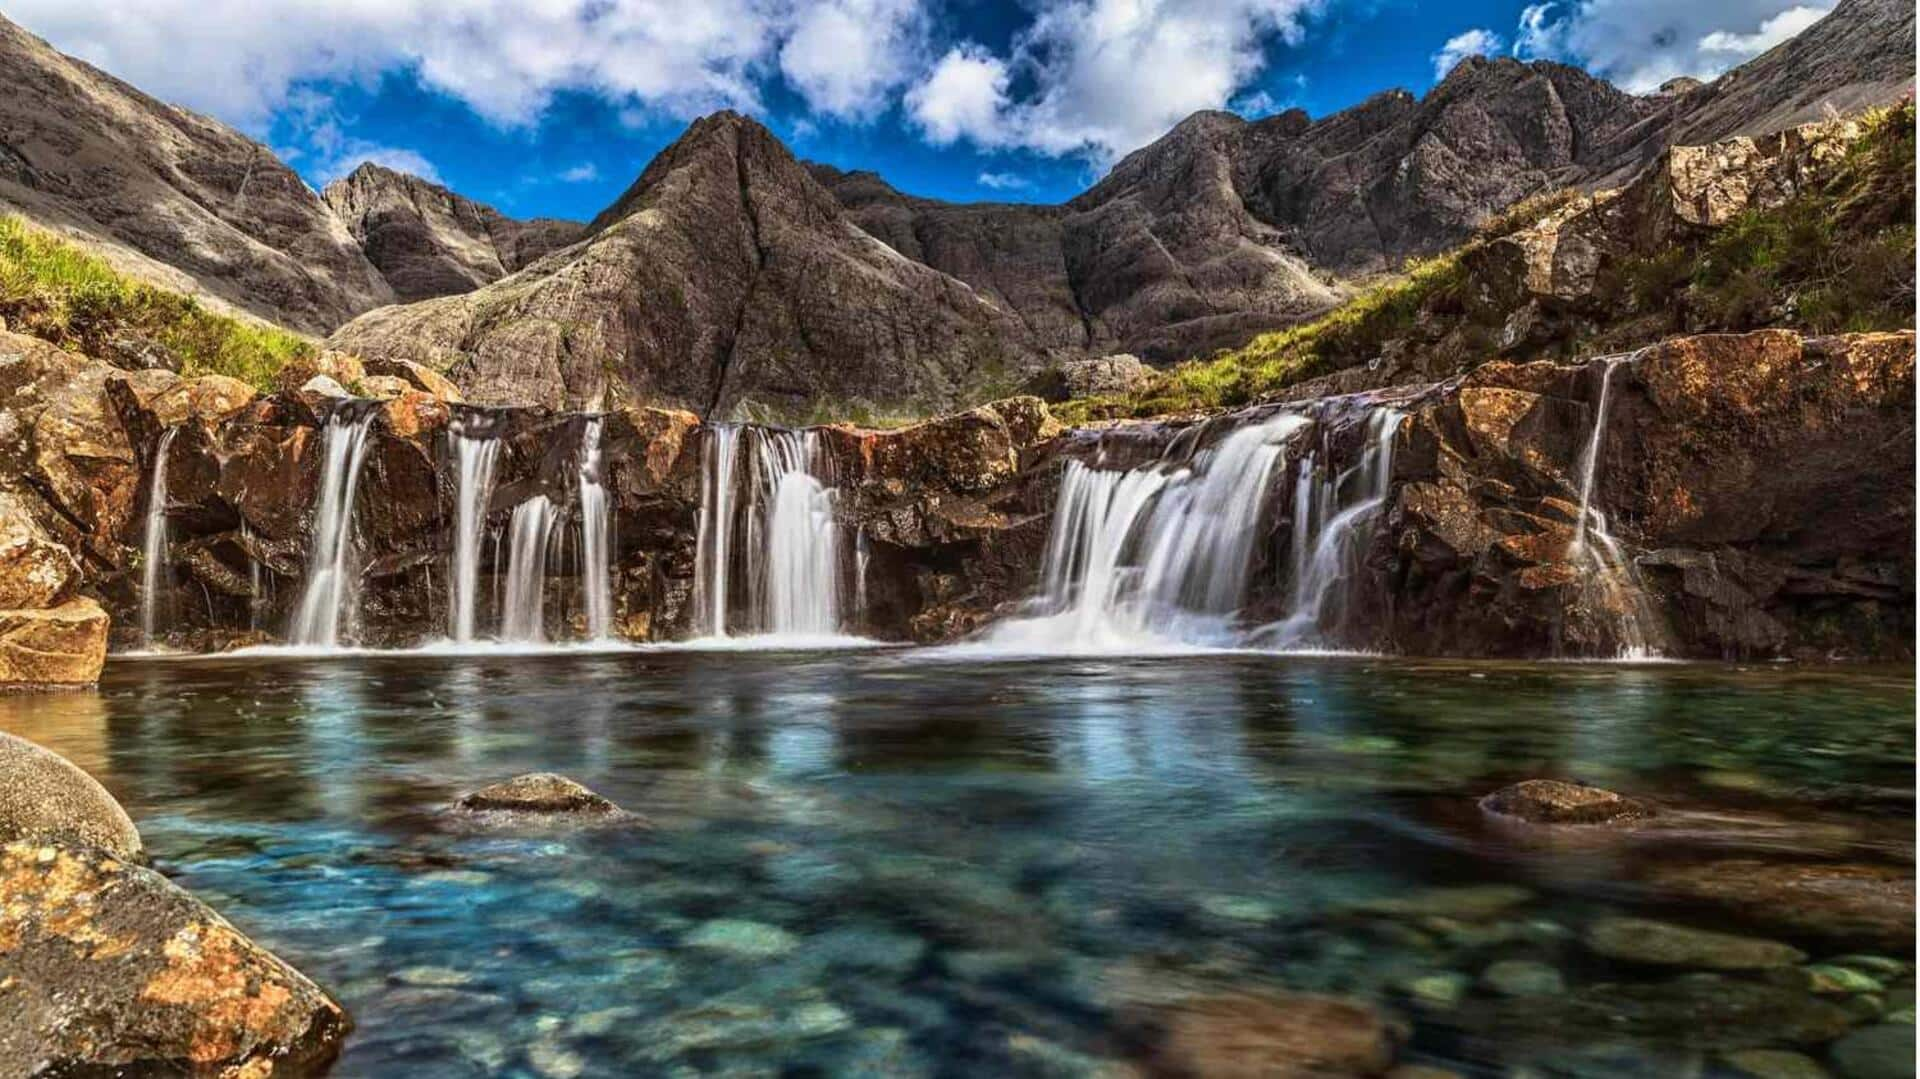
[0,651,1914,1075]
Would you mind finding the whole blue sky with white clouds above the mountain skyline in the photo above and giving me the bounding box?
[18,0,1832,219]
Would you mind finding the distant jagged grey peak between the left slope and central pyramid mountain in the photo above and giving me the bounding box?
[321,161,584,303]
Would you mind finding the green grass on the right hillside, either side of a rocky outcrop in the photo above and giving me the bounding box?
[1056,102,1914,422]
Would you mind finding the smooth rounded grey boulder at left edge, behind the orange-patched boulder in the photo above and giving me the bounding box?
[0,733,140,858]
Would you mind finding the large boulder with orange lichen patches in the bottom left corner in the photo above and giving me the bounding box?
[0,843,351,1077]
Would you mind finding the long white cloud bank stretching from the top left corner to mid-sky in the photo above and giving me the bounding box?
[8,0,924,131]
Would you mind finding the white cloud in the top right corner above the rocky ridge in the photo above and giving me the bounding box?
[1513,0,1832,94]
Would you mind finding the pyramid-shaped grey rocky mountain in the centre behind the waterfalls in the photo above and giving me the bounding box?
[332,113,1044,417]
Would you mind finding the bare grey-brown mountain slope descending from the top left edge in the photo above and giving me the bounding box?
[0,19,394,332]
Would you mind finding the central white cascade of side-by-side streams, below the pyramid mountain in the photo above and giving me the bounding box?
[695,424,843,637]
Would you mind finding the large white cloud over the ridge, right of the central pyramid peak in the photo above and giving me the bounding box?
[908,0,1319,161]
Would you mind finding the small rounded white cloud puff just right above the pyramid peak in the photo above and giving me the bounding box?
[780,0,927,119]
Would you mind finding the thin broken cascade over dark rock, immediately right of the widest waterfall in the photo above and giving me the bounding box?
[1260,407,1402,649]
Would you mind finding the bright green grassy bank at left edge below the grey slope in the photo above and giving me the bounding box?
[0,215,317,390]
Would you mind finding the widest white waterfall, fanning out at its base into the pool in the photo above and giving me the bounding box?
[989,413,1311,651]
